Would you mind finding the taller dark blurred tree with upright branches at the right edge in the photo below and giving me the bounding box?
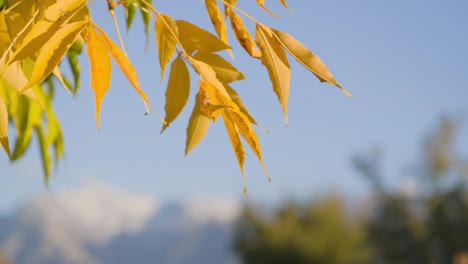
[353,117,468,264]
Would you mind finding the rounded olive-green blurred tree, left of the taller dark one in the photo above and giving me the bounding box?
[235,196,369,264]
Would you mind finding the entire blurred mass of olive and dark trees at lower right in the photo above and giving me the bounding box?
[234,118,468,264]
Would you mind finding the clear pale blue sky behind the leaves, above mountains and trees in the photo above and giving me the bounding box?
[0,0,468,212]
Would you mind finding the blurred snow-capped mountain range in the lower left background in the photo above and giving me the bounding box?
[0,183,240,264]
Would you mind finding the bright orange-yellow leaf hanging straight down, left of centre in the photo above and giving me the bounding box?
[86,26,112,128]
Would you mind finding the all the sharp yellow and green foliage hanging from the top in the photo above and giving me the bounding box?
[0,0,350,194]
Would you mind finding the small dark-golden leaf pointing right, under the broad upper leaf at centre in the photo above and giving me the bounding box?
[193,52,245,83]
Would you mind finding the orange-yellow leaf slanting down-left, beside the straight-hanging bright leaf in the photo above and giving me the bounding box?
[20,22,87,93]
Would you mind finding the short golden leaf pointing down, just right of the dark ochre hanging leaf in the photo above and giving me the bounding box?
[185,95,210,155]
